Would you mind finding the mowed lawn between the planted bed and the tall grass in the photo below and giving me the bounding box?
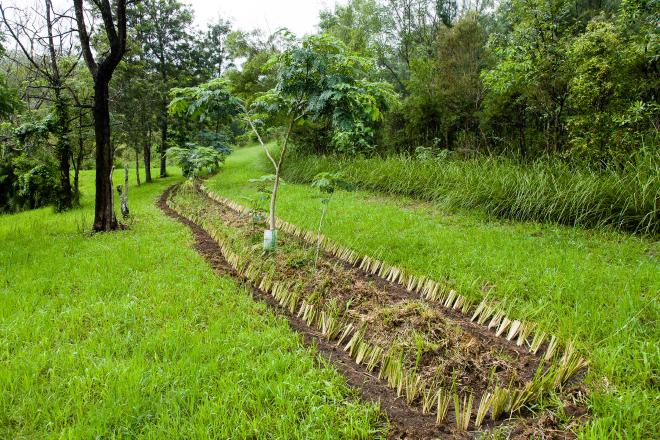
[207,147,660,439]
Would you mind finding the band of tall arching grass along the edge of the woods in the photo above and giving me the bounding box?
[284,150,660,235]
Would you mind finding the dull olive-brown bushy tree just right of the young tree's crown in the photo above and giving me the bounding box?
[386,13,491,151]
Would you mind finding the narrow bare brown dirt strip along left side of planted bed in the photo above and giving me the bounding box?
[157,186,452,439]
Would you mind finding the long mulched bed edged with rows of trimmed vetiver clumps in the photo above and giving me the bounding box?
[168,183,586,430]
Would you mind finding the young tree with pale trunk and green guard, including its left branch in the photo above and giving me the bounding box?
[169,31,396,252]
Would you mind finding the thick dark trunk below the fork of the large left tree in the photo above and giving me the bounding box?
[93,78,118,231]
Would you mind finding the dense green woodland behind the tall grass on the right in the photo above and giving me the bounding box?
[320,0,660,166]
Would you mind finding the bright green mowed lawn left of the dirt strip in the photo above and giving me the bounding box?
[0,168,383,439]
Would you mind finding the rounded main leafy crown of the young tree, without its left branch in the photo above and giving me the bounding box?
[253,34,396,154]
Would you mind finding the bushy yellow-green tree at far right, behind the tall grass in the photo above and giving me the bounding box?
[567,14,660,163]
